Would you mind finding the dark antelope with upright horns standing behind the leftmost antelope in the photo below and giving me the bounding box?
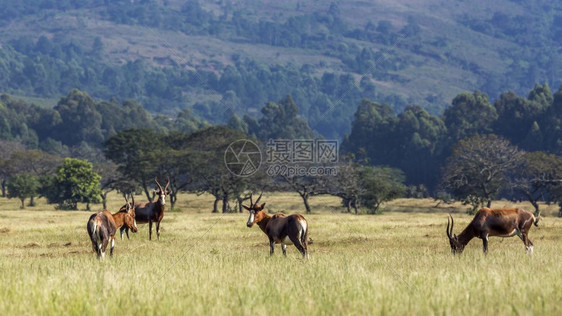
[121,178,170,240]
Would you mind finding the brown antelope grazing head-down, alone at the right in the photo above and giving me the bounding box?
[447,208,537,254]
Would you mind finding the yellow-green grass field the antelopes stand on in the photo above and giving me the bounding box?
[0,193,562,315]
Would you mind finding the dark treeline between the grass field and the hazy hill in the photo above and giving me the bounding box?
[0,84,562,215]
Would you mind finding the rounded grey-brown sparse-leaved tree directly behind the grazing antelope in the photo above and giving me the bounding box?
[442,134,522,212]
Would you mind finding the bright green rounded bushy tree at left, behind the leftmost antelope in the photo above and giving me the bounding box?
[43,158,101,210]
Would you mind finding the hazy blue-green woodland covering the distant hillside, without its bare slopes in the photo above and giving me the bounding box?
[0,0,562,138]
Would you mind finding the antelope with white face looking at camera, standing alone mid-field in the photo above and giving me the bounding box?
[243,194,308,258]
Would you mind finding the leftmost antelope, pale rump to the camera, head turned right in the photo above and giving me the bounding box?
[87,201,137,259]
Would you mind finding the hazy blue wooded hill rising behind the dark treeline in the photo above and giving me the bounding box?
[0,0,562,138]
